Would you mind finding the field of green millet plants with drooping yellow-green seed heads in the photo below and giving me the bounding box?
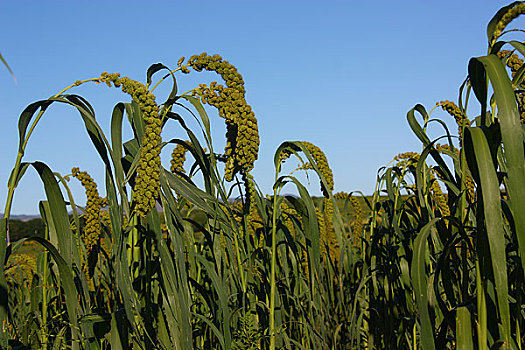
[0,2,525,350]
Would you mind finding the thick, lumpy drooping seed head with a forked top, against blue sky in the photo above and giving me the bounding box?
[179,53,259,181]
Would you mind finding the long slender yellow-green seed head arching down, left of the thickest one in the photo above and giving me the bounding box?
[100,72,162,217]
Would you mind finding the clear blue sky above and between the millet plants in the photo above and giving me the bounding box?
[0,0,508,214]
